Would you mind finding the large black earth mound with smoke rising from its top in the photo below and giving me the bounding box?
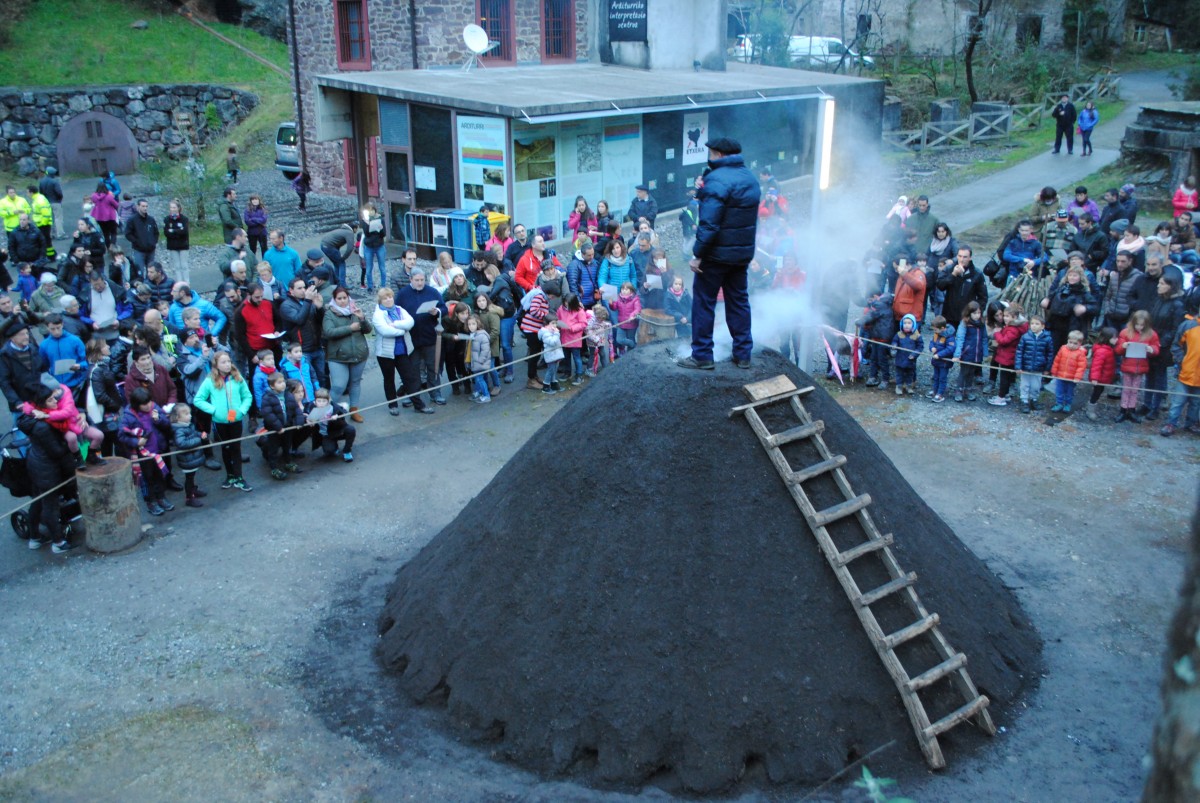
[380,344,1042,792]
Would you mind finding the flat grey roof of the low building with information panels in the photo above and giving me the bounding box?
[316,61,876,121]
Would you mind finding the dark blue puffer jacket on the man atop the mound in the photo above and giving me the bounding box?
[691,154,761,268]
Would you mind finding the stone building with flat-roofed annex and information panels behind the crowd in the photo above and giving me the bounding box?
[282,0,883,239]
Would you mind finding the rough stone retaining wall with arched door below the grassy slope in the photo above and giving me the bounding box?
[0,84,258,175]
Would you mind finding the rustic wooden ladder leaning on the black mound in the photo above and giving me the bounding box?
[730,376,996,769]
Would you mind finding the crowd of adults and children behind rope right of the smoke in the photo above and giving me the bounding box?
[857,178,1200,437]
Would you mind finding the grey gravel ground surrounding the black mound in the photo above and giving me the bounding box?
[0,123,1200,803]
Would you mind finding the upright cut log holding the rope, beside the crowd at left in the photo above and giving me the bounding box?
[76,457,142,553]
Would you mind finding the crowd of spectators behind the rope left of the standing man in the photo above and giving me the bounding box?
[0,165,691,552]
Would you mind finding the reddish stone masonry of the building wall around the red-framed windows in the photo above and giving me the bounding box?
[288,0,598,193]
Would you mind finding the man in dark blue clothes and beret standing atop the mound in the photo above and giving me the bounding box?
[679,137,760,371]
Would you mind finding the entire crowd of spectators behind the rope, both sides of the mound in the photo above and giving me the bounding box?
[0,156,1200,552]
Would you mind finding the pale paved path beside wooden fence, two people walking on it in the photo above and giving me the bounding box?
[931,71,1172,232]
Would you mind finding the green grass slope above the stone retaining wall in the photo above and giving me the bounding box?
[0,0,288,86]
